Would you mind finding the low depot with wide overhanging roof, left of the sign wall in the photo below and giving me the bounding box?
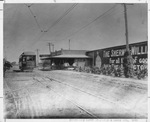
[40,49,92,68]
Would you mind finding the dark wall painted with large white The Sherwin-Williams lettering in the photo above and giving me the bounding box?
[87,41,148,70]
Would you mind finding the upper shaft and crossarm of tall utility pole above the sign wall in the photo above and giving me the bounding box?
[123,3,133,51]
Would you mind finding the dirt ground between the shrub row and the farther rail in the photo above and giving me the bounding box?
[39,71,148,116]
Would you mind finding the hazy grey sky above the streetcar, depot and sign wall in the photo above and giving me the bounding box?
[3,3,148,62]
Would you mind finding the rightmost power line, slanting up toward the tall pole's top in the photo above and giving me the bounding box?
[59,4,116,40]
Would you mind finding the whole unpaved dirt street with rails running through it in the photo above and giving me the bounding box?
[4,69,148,118]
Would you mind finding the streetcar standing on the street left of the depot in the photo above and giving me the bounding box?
[19,52,36,71]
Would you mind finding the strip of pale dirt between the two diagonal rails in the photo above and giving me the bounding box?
[35,76,145,118]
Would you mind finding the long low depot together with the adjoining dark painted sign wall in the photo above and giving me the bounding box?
[40,41,148,70]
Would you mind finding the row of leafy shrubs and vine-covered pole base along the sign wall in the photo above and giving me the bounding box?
[75,60,148,79]
